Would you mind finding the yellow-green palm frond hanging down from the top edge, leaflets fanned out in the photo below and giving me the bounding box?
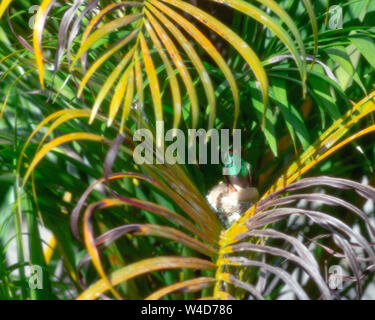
[30,0,316,128]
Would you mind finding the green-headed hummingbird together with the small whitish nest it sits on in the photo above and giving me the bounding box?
[206,155,259,229]
